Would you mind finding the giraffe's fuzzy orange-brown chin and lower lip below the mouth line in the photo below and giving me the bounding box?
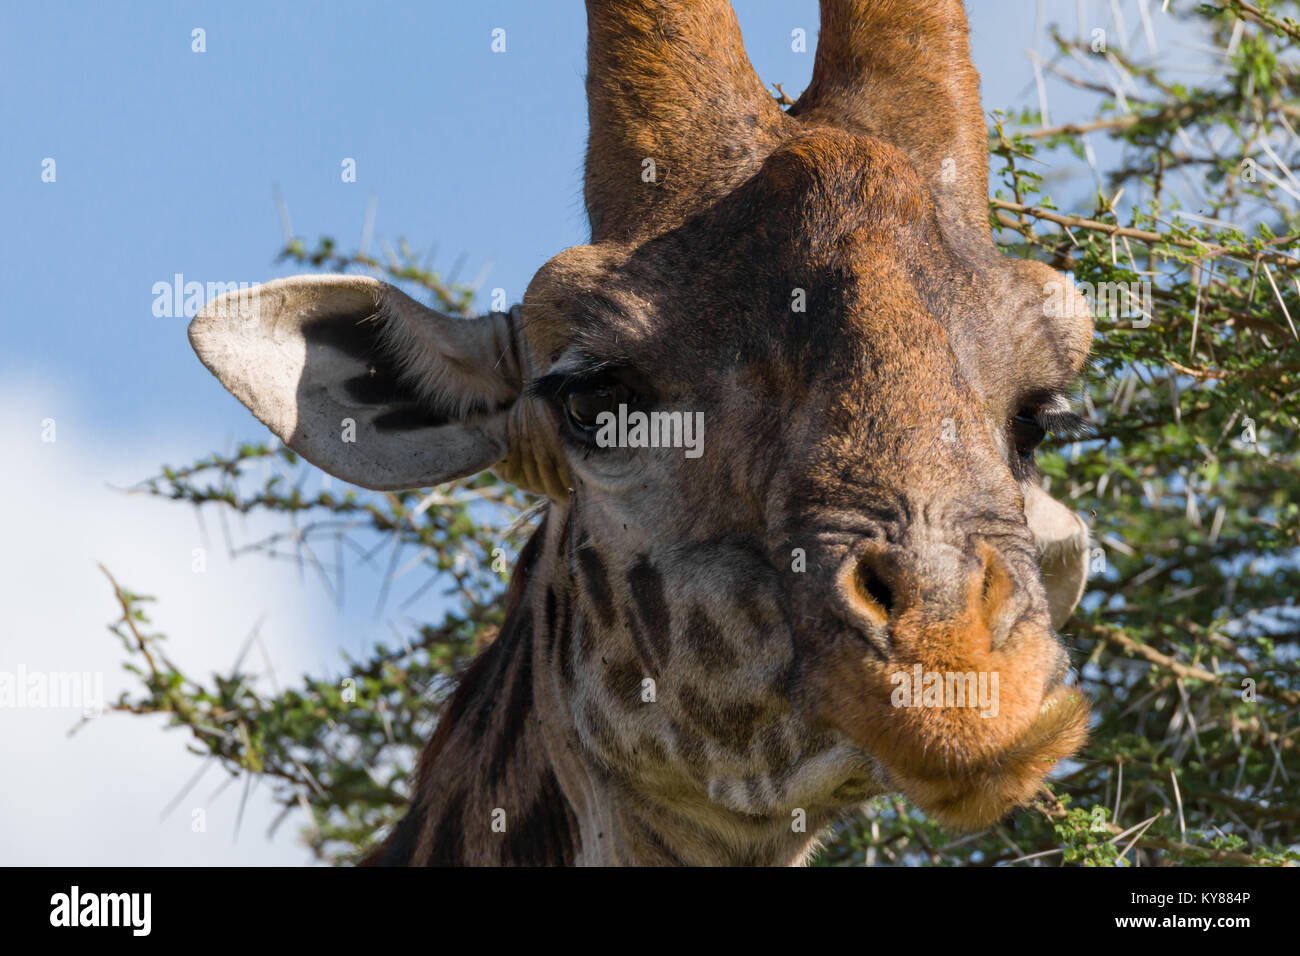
[889,687,1088,830]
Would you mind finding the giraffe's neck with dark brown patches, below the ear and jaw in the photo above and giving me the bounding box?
[365,506,814,866]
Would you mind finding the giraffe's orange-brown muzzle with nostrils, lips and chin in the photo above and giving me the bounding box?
[824,541,1088,829]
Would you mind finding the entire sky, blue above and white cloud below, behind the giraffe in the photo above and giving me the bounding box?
[0,0,1180,862]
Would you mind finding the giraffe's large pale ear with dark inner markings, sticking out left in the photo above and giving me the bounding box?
[190,276,521,490]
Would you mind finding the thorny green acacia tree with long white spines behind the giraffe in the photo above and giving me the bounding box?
[96,0,1300,865]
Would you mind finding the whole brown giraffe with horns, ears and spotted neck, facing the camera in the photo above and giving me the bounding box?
[190,0,1092,865]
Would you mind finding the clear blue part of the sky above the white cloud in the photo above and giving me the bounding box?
[0,0,1118,458]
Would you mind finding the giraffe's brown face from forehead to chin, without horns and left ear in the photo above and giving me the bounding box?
[501,130,1091,825]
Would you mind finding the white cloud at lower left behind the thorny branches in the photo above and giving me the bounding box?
[0,385,353,865]
